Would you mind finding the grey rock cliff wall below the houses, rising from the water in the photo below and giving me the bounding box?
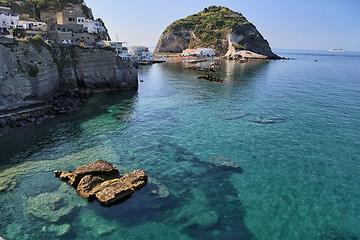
[0,37,138,127]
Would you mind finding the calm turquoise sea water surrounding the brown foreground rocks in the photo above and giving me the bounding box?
[0,50,360,240]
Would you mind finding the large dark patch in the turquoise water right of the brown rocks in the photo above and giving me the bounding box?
[94,141,253,239]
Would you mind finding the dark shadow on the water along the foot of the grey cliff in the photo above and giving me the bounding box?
[0,90,137,166]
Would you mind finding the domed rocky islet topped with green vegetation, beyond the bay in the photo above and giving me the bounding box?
[155,6,279,59]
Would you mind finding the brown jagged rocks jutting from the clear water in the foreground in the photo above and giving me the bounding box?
[54,160,148,205]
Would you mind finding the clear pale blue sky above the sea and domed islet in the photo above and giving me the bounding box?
[85,0,360,51]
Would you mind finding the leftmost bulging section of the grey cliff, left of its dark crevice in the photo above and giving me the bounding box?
[0,42,62,106]
